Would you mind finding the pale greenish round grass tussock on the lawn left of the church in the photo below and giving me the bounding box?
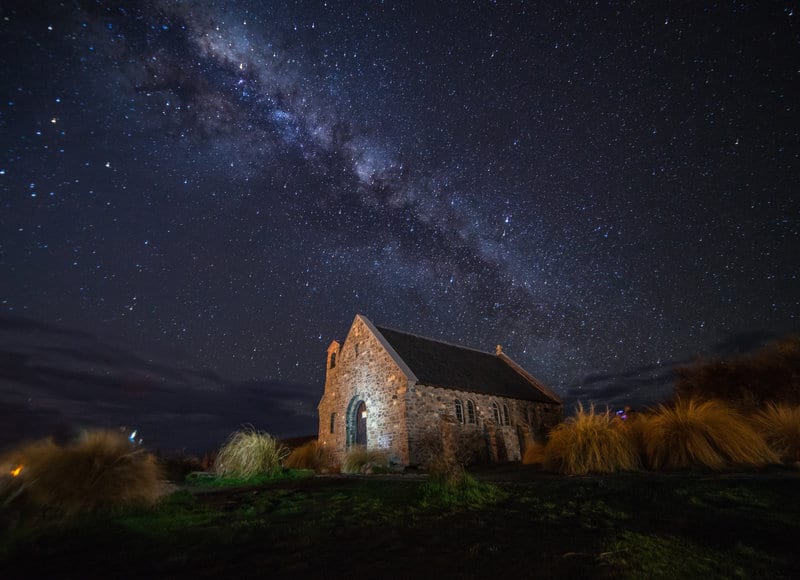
[214,427,289,477]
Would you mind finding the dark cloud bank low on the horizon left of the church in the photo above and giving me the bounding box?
[0,316,320,452]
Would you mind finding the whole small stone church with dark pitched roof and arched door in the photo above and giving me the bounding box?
[318,315,562,465]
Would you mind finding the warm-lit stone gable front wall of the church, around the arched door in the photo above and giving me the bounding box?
[318,317,409,464]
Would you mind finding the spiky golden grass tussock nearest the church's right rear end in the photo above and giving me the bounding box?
[545,404,639,475]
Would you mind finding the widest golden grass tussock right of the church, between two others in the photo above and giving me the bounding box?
[644,399,778,471]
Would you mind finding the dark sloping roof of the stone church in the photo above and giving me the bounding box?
[376,327,559,403]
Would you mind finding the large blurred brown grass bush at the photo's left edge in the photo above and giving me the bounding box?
[0,430,164,515]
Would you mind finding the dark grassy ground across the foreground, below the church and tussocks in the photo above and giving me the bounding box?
[0,467,800,578]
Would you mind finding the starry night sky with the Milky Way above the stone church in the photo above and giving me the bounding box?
[0,0,800,449]
